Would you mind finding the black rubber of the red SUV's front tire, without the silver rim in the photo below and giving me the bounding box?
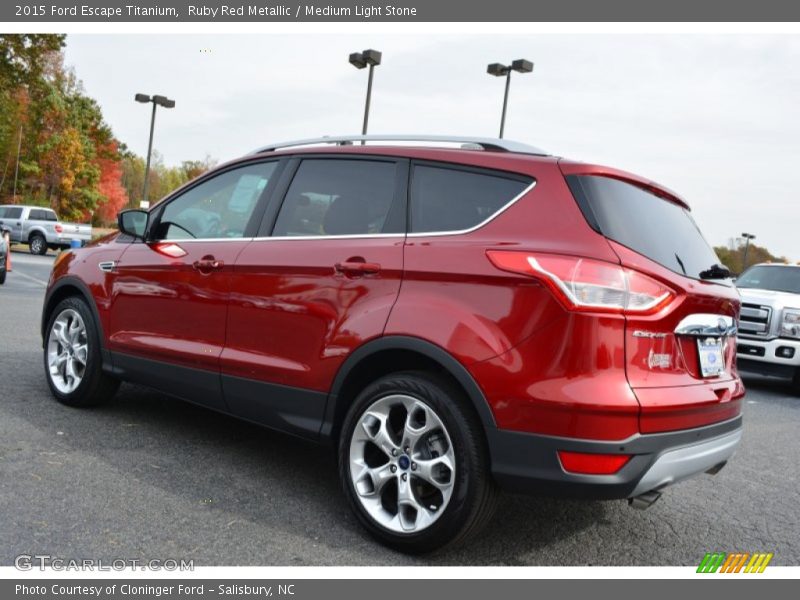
[43,296,119,407]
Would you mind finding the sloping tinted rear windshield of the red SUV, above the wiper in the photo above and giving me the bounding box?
[567,175,719,279]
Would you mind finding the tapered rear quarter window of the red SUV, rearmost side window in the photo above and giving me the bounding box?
[411,165,533,233]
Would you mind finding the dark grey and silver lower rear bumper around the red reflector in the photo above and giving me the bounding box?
[489,416,742,499]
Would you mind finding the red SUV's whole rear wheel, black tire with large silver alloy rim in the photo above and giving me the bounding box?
[339,372,496,554]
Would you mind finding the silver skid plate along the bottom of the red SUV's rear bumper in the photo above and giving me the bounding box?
[629,429,742,498]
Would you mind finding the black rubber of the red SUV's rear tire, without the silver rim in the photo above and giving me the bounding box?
[338,371,497,554]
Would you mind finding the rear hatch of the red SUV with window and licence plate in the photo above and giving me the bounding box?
[560,161,744,433]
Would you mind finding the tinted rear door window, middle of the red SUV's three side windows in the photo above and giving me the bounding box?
[272,159,397,237]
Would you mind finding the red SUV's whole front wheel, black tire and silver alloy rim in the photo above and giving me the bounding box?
[44,296,119,406]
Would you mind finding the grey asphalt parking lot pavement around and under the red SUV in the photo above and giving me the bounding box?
[0,253,800,565]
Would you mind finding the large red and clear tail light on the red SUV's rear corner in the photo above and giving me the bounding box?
[487,250,675,315]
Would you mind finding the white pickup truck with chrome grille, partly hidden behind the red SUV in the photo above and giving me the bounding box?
[736,263,800,393]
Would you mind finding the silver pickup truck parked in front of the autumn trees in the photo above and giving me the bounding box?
[0,204,92,254]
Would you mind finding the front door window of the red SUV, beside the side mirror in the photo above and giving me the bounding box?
[155,161,278,240]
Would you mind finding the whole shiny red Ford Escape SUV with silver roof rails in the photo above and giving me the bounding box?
[42,136,744,552]
